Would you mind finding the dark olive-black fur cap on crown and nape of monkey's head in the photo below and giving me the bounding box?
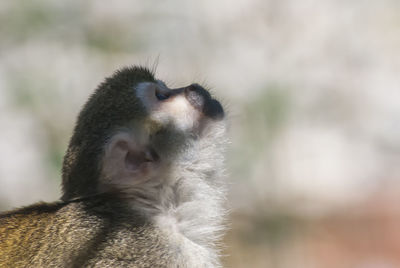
[62,66,155,201]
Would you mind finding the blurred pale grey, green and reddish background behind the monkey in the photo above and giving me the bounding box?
[0,0,400,268]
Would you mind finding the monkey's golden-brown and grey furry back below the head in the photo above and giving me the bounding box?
[0,196,180,267]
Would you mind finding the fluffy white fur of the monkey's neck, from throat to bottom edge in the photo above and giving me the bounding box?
[126,142,225,267]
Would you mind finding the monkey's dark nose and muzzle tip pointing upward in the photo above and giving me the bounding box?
[185,84,224,119]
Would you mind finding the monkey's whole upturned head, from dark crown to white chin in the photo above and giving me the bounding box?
[62,67,225,200]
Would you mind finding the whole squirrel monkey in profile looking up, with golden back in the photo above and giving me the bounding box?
[0,66,228,267]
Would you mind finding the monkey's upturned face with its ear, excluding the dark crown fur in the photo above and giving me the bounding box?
[99,69,224,195]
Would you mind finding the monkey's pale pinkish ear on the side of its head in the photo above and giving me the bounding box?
[101,133,154,185]
